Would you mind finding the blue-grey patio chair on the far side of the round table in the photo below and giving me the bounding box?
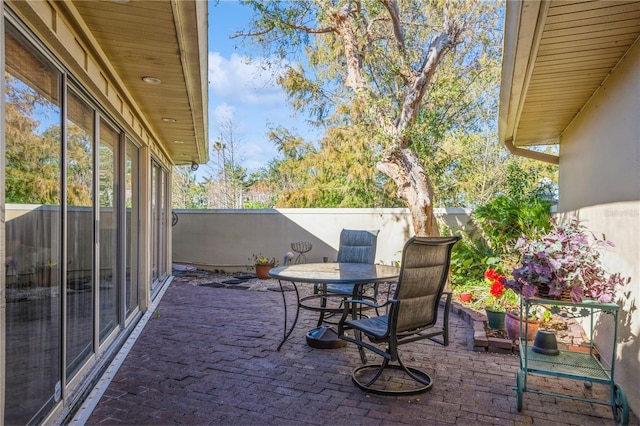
[315,229,380,327]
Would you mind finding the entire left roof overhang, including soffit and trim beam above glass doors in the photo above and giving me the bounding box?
[20,0,209,165]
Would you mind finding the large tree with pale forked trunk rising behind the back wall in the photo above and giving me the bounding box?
[238,0,498,235]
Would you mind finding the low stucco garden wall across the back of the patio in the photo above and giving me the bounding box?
[172,208,469,272]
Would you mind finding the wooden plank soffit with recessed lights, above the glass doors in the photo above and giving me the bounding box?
[73,0,208,165]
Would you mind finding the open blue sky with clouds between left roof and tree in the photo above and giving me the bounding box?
[208,0,318,173]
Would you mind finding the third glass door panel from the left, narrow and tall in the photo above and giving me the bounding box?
[98,121,120,343]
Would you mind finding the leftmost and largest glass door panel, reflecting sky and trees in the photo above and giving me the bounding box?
[0,21,62,424]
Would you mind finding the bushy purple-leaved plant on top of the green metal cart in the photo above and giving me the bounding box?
[504,217,629,303]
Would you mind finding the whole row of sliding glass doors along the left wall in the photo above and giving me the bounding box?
[0,17,142,424]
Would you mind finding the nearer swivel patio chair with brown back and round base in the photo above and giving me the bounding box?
[338,236,460,395]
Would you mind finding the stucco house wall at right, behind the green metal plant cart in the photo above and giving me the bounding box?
[558,43,640,413]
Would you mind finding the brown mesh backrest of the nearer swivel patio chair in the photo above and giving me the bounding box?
[389,236,460,333]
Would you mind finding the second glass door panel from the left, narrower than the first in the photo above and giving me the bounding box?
[65,90,95,378]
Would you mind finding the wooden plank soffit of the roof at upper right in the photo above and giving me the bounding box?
[499,0,640,147]
